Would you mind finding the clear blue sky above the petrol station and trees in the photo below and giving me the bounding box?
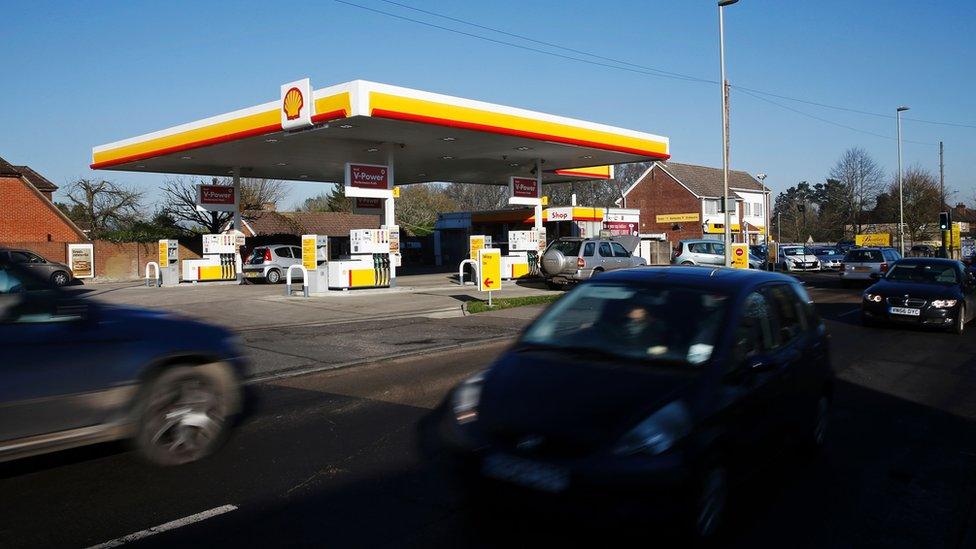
[0,0,976,208]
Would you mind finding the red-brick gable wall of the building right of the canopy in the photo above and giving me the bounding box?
[627,168,702,242]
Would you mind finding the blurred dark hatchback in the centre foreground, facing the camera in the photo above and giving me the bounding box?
[421,267,833,537]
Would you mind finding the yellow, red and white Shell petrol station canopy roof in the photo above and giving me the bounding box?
[91,80,670,185]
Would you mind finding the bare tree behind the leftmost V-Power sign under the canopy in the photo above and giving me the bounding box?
[162,177,289,234]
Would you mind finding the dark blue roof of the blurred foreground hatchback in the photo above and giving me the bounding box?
[588,265,798,294]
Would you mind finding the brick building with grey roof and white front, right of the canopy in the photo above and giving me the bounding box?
[624,162,770,244]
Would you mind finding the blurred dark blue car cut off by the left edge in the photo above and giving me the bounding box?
[0,258,244,465]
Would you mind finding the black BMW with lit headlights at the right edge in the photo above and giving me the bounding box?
[861,258,976,334]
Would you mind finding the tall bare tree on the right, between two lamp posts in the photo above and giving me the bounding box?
[830,147,885,234]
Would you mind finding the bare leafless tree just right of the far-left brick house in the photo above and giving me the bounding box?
[68,179,142,238]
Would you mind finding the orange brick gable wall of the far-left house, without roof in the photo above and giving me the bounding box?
[0,177,82,245]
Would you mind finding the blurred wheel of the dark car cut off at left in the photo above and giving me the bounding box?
[135,363,240,466]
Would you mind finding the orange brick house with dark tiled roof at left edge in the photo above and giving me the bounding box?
[0,158,88,246]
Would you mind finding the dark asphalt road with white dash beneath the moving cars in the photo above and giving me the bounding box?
[0,276,976,548]
